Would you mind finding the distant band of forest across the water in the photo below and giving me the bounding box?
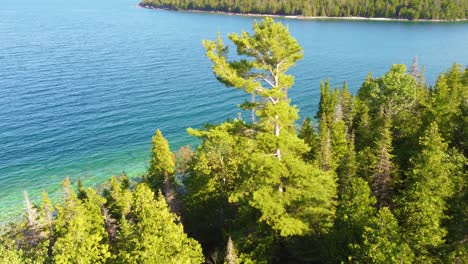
[140,0,468,20]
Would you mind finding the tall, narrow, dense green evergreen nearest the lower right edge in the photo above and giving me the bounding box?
[398,123,454,263]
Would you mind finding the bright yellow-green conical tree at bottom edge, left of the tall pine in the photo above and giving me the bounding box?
[116,184,203,263]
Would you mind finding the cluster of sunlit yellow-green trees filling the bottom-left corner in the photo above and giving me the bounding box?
[0,174,203,264]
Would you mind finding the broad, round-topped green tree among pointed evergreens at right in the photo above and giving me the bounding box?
[354,65,427,169]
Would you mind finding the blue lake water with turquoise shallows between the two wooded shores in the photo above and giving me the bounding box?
[0,0,468,220]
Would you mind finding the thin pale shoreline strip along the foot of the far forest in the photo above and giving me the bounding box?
[135,3,468,23]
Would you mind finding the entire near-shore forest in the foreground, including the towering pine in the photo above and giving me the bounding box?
[0,18,468,264]
